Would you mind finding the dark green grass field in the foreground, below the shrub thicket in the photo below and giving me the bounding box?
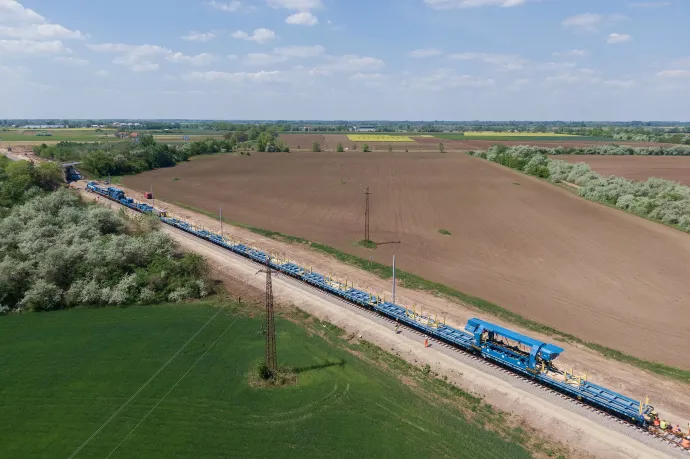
[0,303,558,458]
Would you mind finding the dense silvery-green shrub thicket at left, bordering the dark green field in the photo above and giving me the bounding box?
[0,189,210,311]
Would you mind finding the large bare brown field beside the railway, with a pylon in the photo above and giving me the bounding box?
[124,152,690,369]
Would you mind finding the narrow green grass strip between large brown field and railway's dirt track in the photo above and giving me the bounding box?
[165,203,690,384]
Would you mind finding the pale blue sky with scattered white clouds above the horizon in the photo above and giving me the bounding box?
[0,0,690,120]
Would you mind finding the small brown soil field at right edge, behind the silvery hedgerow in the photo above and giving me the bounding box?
[552,155,690,186]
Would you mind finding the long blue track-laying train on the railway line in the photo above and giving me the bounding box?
[86,182,658,427]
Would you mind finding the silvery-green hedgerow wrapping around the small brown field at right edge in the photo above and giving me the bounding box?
[469,145,690,233]
